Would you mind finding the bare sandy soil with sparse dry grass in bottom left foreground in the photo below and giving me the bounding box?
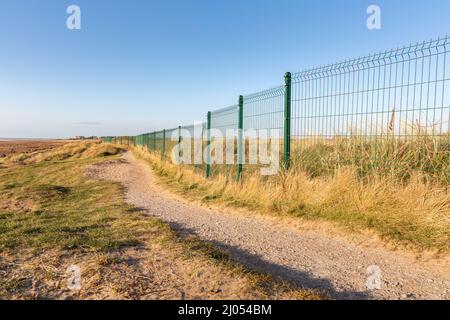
[0,244,295,300]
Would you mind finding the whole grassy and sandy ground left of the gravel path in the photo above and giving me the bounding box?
[0,143,319,299]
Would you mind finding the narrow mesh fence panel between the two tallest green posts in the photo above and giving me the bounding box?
[243,86,284,174]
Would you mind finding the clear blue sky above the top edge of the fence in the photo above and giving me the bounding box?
[0,0,450,137]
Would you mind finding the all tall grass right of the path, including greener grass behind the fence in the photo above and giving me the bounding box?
[134,136,450,252]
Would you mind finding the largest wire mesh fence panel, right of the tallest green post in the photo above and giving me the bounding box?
[291,38,450,178]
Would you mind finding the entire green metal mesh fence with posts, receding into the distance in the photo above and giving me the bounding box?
[104,37,450,181]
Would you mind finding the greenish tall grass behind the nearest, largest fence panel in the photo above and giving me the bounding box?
[293,134,450,184]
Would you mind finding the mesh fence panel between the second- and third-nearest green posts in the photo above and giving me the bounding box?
[210,105,239,179]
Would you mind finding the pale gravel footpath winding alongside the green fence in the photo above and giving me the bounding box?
[89,152,450,299]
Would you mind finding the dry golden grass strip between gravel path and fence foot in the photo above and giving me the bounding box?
[134,148,450,253]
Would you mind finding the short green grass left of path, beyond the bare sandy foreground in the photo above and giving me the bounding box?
[0,146,157,251]
